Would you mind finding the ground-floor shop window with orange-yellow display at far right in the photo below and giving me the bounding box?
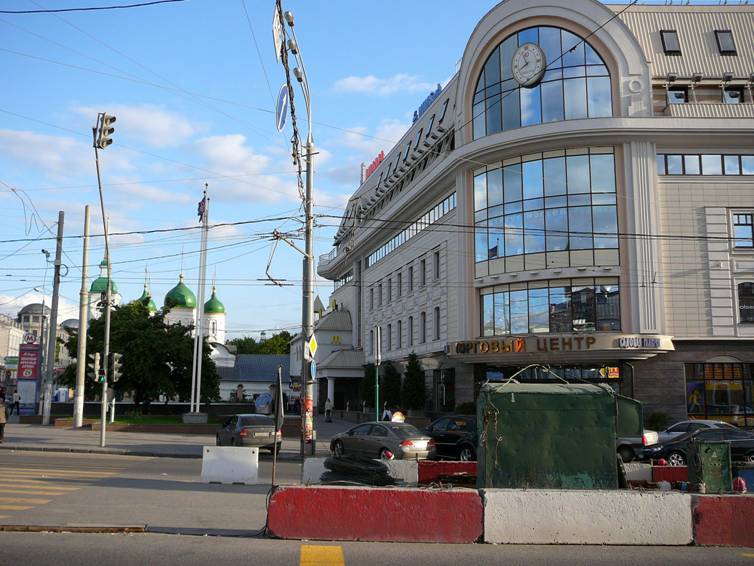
[686,363,754,426]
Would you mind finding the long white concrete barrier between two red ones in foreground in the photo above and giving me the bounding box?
[481,489,692,545]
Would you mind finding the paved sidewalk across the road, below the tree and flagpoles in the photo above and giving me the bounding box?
[0,417,353,460]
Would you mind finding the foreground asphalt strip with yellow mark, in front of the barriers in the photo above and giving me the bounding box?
[0,533,754,566]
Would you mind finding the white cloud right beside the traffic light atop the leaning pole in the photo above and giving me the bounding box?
[74,104,200,147]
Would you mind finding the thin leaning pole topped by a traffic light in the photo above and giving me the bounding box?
[92,112,115,448]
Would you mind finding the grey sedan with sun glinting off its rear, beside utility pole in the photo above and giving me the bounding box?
[330,421,435,460]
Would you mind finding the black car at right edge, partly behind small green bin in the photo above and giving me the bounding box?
[642,428,754,466]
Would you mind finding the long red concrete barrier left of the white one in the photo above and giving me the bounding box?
[267,486,483,543]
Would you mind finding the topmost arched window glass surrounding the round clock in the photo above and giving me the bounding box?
[472,26,613,139]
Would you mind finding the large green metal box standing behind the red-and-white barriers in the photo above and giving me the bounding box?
[477,383,618,489]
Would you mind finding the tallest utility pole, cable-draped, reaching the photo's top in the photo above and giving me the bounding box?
[274,0,317,456]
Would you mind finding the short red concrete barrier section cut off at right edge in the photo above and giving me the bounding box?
[693,495,754,547]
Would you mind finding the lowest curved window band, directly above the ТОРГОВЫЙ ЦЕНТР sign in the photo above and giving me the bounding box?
[481,278,621,336]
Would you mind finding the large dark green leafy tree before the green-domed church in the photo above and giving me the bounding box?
[60,301,220,408]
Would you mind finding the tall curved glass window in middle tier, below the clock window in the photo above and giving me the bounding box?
[474,148,618,271]
